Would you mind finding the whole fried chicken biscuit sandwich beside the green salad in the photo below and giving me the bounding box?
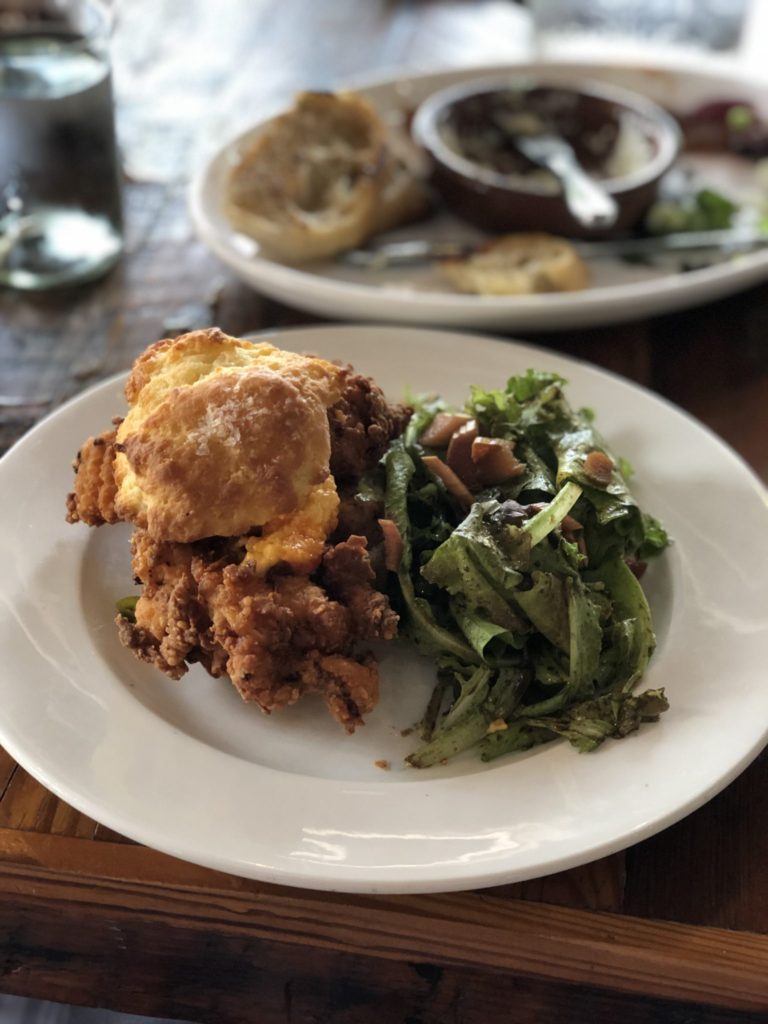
[67,329,408,732]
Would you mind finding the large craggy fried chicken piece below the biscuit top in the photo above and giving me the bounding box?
[118,529,397,732]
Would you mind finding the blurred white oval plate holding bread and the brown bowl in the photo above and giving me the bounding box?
[190,63,768,330]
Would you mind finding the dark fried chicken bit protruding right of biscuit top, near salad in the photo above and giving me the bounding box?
[328,368,412,483]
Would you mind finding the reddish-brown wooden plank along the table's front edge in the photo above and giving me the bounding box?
[0,829,768,1011]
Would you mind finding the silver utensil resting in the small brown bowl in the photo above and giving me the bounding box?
[514,132,618,228]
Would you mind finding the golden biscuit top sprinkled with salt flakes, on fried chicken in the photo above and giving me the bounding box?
[115,329,342,543]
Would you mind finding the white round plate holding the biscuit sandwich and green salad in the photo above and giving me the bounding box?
[0,327,768,892]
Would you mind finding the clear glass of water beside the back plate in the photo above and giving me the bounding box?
[0,0,123,289]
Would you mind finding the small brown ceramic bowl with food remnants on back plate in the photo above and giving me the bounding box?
[413,74,681,238]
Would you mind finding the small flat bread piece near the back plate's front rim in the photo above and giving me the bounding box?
[438,232,589,295]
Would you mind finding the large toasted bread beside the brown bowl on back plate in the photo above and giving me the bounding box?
[224,92,428,263]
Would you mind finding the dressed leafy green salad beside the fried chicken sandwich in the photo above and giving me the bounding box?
[384,371,669,768]
